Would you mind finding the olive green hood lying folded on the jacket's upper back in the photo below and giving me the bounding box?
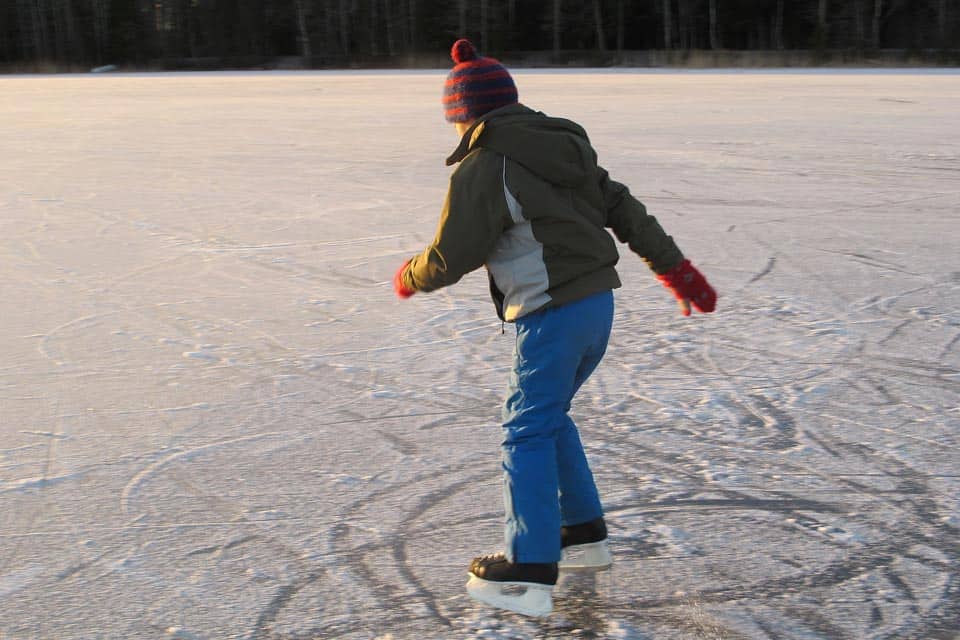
[447,104,597,187]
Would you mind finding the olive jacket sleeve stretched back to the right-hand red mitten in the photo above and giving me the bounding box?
[597,167,683,274]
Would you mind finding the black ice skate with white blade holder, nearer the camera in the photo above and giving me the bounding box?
[467,553,557,616]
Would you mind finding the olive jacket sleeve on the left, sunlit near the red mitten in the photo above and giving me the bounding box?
[403,151,510,291]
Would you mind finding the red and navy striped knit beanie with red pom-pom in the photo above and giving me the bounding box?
[443,39,517,122]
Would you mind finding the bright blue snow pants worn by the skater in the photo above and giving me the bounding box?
[501,291,613,562]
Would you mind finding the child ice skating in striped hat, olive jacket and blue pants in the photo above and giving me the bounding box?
[394,40,717,616]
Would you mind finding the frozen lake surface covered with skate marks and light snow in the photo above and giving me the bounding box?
[0,71,960,640]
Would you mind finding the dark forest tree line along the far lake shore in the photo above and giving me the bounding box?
[0,0,960,69]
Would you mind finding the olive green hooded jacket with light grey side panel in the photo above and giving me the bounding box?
[402,104,683,321]
